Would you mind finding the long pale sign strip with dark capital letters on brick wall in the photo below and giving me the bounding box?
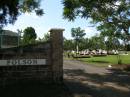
[0,59,46,66]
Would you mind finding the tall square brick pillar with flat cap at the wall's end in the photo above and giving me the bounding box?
[50,28,64,83]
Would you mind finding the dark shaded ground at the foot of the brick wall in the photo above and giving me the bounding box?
[0,82,72,97]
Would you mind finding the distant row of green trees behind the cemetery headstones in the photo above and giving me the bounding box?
[64,33,125,51]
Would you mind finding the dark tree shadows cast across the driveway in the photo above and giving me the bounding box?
[64,69,130,97]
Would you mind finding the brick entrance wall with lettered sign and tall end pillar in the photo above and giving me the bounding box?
[0,28,64,85]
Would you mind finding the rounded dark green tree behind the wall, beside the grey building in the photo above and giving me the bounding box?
[23,27,37,45]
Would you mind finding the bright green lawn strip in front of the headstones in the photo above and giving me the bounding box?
[78,52,130,66]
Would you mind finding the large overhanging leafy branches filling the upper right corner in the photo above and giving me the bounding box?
[63,0,130,40]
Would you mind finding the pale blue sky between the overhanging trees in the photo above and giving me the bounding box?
[4,0,99,39]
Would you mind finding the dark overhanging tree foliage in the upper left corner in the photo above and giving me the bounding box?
[0,0,43,28]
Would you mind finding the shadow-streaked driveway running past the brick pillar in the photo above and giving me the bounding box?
[64,60,130,97]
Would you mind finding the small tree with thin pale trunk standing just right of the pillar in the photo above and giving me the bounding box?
[71,27,86,53]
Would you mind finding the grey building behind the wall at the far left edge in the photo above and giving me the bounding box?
[0,30,19,48]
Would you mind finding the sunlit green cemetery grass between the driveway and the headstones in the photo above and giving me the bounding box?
[69,51,130,67]
